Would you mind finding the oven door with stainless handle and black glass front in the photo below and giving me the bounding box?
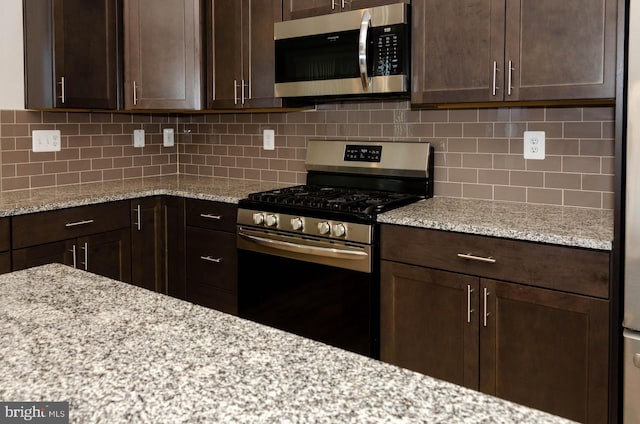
[238,226,379,358]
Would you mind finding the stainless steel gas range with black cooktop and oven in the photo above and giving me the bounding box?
[237,140,433,357]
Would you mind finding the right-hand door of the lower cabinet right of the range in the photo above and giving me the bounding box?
[480,280,609,423]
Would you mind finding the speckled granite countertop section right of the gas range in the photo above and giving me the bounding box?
[378,197,613,250]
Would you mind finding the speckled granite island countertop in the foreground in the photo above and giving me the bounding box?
[0,264,567,424]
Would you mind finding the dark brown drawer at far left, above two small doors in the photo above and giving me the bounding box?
[11,200,130,249]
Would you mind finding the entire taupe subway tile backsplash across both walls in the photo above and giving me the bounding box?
[0,101,615,209]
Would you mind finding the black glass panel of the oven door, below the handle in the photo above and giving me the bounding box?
[238,250,379,357]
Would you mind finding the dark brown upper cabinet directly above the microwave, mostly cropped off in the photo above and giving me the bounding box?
[282,0,409,21]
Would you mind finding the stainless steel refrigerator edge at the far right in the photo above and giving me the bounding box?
[623,2,640,424]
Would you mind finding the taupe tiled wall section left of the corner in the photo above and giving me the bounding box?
[0,110,178,191]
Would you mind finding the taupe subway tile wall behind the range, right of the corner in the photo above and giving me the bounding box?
[179,102,615,209]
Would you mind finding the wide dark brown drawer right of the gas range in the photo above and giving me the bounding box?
[381,225,609,298]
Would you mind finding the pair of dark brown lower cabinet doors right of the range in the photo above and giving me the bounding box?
[380,260,609,423]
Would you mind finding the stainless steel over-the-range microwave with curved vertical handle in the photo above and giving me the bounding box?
[274,3,411,97]
